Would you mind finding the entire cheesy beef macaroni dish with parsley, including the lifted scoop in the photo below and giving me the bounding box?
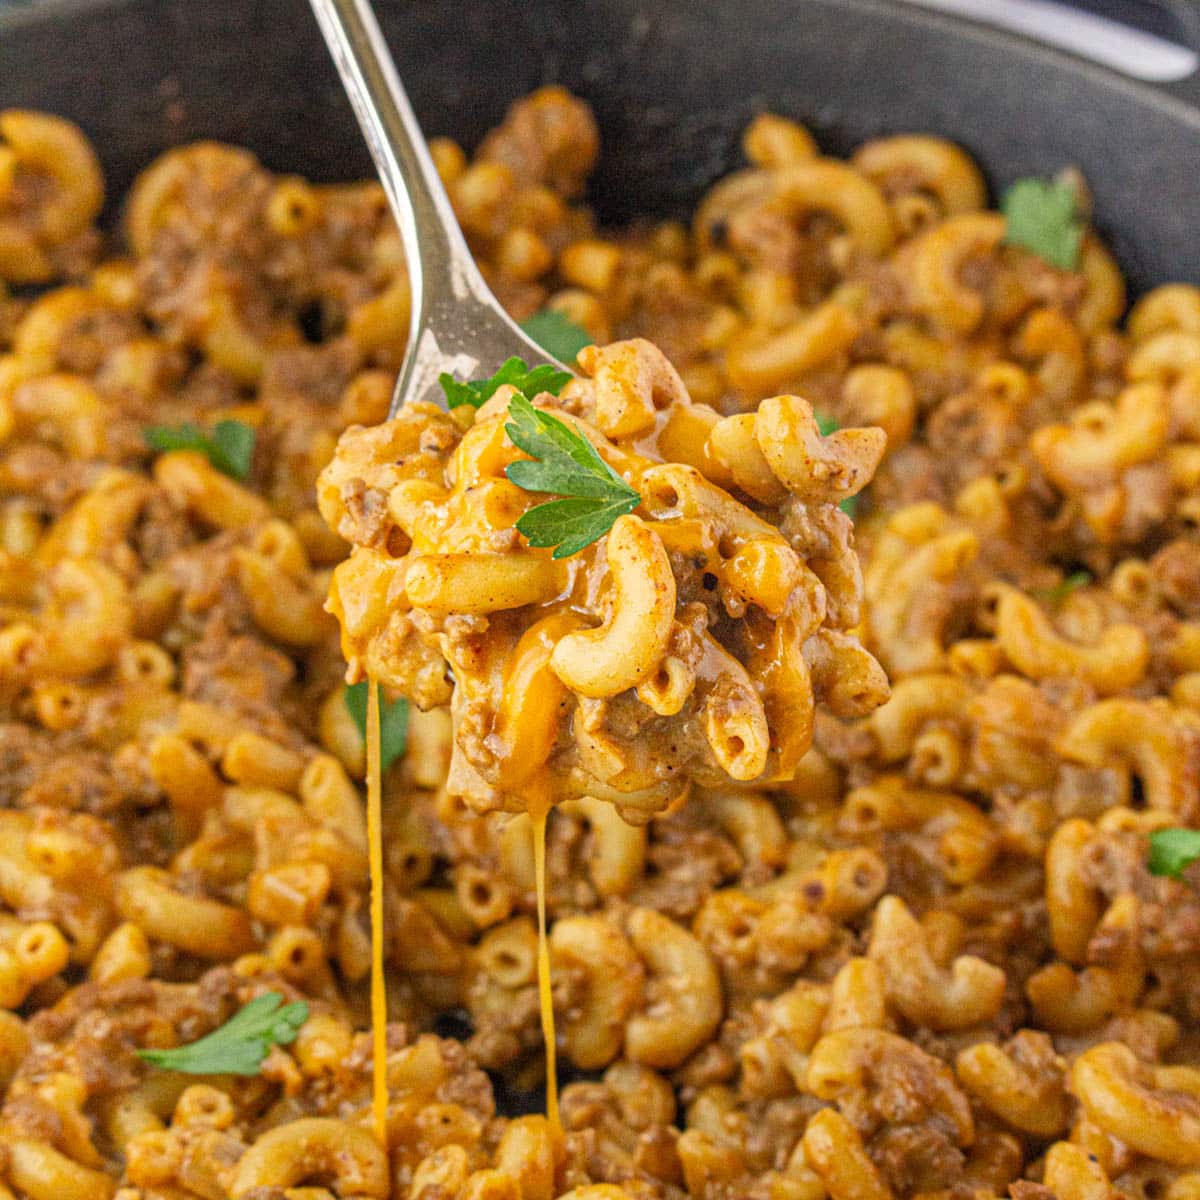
[0,86,1200,1200]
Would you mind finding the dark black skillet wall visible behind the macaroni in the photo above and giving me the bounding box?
[0,0,1200,290]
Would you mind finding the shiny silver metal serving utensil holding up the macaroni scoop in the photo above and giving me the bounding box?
[310,0,562,416]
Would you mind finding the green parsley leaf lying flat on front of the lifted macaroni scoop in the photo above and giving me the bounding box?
[504,396,642,558]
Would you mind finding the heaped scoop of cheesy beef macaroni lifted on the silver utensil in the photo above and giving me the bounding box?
[318,340,888,820]
